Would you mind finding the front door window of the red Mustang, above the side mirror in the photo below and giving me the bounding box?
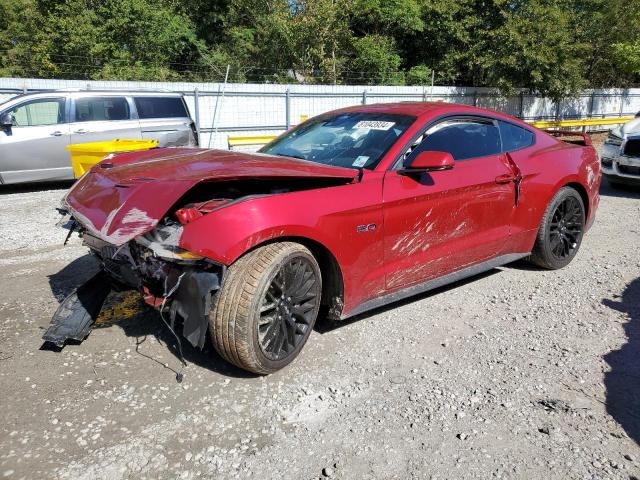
[409,119,501,161]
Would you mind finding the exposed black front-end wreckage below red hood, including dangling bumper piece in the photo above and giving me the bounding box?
[43,217,225,348]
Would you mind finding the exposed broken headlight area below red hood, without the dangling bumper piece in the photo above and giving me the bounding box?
[84,222,225,348]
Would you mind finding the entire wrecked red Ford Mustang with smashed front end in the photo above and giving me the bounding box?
[44,103,601,374]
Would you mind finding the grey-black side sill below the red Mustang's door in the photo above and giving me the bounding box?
[341,252,531,320]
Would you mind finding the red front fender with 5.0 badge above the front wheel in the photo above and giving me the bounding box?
[179,176,384,312]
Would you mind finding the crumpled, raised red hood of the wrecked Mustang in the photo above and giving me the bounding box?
[63,148,358,245]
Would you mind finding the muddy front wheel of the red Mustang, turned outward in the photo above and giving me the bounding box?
[209,242,322,374]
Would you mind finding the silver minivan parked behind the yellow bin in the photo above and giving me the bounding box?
[0,90,198,183]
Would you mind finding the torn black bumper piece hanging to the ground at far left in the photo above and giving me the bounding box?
[42,271,111,348]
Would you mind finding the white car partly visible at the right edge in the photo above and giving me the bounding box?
[601,113,640,186]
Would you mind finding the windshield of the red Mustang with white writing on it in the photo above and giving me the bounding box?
[260,112,416,169]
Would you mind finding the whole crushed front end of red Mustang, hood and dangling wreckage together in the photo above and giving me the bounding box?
[44,144,359,347]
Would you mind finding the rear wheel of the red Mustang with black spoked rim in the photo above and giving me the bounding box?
[529,187,585,270]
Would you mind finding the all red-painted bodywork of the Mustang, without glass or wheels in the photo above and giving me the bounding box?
[60,103,600,317]
